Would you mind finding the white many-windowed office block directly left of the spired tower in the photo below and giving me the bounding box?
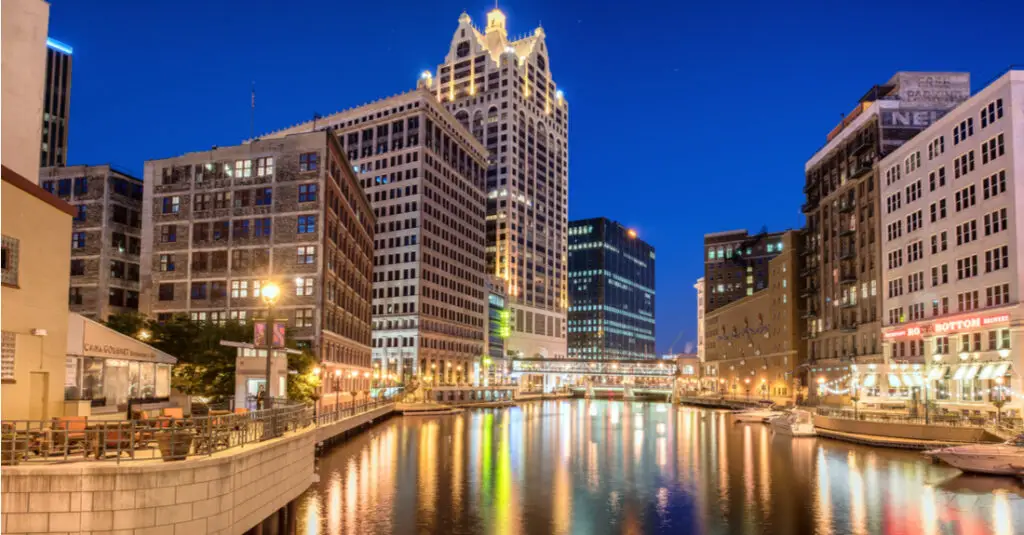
[269,88,487,384]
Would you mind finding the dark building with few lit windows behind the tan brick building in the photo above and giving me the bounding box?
[703,230,785,314]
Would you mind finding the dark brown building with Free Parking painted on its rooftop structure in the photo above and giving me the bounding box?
[802,72,970,380]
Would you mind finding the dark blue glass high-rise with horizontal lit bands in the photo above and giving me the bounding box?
[568,217,657,360]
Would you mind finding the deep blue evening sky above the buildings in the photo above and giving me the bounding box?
[50,0,1024,352]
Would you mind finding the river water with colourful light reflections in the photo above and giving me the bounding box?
[298,400,1024,535]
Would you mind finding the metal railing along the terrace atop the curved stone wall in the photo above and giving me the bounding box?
[0,397,396,465]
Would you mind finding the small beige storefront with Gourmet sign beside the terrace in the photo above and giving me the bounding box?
[65,313,176,414]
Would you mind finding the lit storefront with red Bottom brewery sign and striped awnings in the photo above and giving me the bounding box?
[876,308,1024,418]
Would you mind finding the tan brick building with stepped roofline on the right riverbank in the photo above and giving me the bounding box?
[702,231,807,403]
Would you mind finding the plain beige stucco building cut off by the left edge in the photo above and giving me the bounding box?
[0,0,74,420]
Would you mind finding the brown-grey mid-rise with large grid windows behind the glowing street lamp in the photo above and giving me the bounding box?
[139,132,374,387]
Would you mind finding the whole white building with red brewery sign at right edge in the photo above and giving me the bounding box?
[876,70,1024,417]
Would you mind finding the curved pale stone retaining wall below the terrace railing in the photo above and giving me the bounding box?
[0,428,317,535]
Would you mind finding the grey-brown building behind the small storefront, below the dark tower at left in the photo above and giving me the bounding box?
[39,165,142,321]
